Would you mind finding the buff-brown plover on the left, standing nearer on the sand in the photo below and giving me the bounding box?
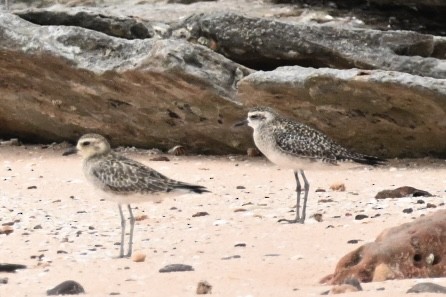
[63,134,209,258]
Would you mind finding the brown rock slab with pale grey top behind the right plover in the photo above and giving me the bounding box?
[238,66,446,157]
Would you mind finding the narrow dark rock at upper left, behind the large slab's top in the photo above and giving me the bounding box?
[17,10,154,39]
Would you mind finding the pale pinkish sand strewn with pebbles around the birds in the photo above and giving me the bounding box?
[0,146,446,296]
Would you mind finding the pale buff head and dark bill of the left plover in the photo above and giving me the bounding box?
[64,134,111,159]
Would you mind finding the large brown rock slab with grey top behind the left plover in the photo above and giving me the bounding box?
[0,13,250,153]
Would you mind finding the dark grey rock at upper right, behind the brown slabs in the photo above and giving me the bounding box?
[182,13,446,78]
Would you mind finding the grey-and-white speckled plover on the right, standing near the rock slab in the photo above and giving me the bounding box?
[235,107,385,224]
